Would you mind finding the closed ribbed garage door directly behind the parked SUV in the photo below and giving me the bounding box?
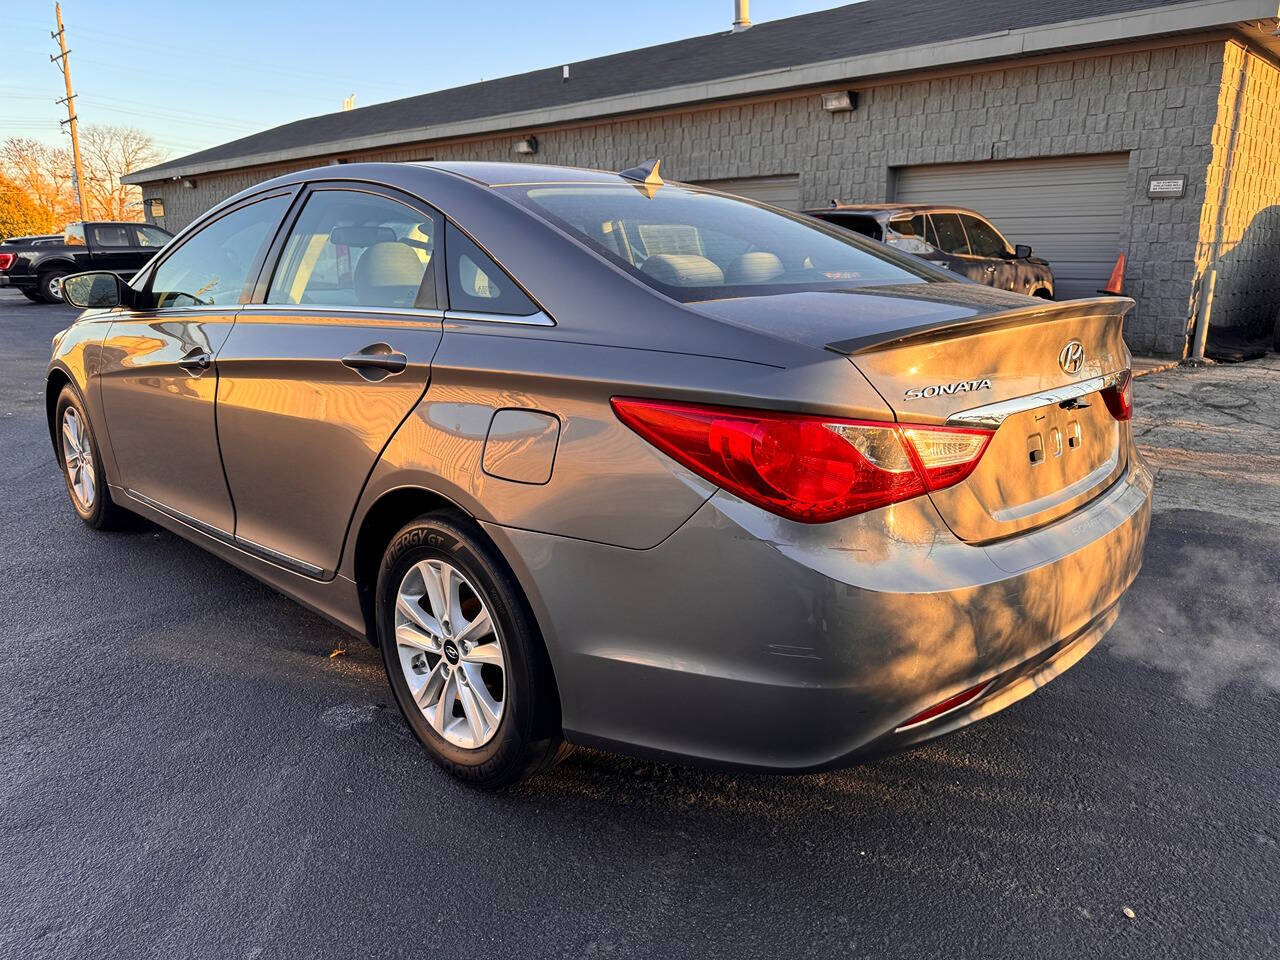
[893,154,1129,300]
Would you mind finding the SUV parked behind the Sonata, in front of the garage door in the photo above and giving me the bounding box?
[805,204,1053,300]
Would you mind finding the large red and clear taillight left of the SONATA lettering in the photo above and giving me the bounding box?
[613,397,992,524]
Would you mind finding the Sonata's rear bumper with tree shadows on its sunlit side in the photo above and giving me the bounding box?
[490,442,1152,772]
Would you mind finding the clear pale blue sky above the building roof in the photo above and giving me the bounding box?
[0,0,840,157]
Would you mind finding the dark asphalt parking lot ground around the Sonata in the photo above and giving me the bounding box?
[0,292,1280,957]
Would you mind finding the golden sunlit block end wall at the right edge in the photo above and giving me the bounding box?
[1196,44,1280,352]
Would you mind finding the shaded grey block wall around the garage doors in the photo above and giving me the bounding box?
[137,41,1225,356]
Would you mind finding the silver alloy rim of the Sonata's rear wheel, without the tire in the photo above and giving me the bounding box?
[396,559,507,750]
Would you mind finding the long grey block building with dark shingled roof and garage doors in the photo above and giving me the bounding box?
[127,0,1280,357]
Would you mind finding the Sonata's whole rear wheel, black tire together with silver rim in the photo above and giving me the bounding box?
[376,512,562,790]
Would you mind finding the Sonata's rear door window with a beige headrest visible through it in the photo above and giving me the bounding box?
[266,189,436,308]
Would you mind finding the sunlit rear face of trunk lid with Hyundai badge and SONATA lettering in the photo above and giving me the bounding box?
[831,298,1132,543]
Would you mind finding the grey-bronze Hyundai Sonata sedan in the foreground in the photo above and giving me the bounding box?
[46,163,1152,787]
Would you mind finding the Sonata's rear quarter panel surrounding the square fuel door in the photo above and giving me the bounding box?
[348,321,888,562]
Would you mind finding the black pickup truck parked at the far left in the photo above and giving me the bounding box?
[0,220,173,303]
